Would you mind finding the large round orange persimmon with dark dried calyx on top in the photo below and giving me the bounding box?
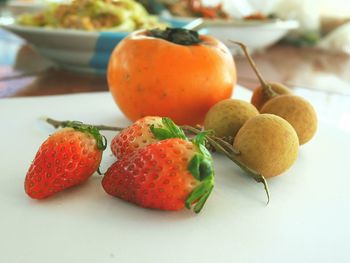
[107,28,236,125]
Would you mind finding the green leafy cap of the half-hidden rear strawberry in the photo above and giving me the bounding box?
[150,117,187,140]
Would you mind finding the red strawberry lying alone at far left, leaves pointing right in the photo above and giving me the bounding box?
[24,122,106,199]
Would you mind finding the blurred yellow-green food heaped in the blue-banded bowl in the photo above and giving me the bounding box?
[17,0,167,31]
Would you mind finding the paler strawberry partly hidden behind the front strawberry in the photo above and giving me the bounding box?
[111,116,186,159]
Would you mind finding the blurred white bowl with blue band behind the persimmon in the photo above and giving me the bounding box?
[0,19,202,73]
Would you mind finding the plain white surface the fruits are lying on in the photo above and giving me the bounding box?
[0,87,350,263]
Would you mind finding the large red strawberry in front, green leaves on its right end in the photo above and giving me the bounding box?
[102,135,214,213]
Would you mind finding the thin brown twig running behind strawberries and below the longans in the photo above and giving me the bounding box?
[45,118,270,204]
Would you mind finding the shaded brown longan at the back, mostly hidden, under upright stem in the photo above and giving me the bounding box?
[250,82,292,111]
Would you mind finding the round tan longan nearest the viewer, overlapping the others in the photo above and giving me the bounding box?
[233,114,299,178]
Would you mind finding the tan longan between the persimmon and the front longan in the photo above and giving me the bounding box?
[204,99,259,137]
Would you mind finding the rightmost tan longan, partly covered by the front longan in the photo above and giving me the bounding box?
[261,95,317,145]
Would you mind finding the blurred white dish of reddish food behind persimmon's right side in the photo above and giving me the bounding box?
[139,0,298,53]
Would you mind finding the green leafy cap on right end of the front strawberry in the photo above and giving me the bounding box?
[185,132,214,213]
